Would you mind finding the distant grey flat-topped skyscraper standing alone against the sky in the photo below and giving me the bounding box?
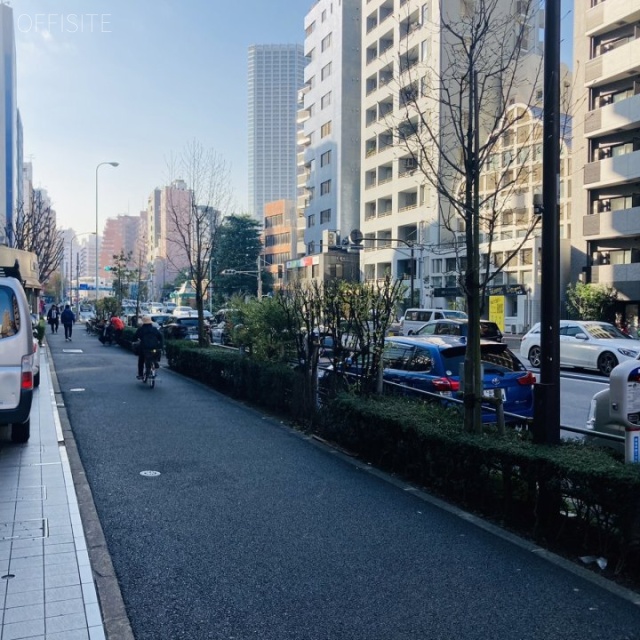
[249,44,305,220]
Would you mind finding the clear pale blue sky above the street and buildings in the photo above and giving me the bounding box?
[12,0,573,233]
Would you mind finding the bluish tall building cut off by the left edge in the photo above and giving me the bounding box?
[0,4,22,245]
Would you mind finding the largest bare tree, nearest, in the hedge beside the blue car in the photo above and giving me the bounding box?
[384,0,541,431]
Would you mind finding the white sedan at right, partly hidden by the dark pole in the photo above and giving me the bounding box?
[520,320,640,376]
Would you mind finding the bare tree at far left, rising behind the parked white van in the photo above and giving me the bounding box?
[12,190,64,284]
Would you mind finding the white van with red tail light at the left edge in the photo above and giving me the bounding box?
[0,277,34,442]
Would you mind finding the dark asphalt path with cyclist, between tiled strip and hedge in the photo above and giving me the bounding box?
[47,327,640,640]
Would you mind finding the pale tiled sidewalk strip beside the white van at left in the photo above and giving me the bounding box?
[0,348,106,640]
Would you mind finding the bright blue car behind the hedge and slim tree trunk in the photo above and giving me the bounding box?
[383,336,536,423]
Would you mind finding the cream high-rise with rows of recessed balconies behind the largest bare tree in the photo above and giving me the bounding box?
[361,0,542,307]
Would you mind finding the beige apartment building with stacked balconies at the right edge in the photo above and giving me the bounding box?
[572,0,640,326]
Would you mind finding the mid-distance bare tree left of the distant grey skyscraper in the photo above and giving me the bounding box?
[166,140,232,346]
